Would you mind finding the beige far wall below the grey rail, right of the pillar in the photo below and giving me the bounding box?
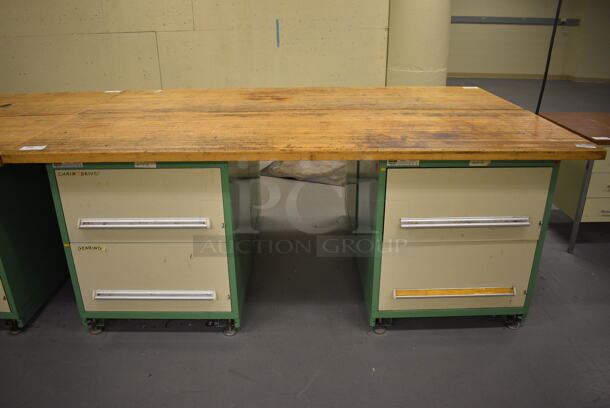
[449,24,574,75]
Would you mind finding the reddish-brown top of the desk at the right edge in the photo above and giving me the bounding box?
[540,112,610,145]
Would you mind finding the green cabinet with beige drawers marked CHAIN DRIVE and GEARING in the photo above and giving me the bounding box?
[48,163,257,334]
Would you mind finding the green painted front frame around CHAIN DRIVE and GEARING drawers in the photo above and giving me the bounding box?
[47,162,241,327]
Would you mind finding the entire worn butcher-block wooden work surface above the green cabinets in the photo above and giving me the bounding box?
[0,87,605,163]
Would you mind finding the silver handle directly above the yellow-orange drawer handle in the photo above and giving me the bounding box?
[400,216,530,228]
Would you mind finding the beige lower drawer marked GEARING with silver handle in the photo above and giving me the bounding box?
[72,243,231,312]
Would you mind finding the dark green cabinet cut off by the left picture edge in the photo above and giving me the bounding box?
[0,165,68,331]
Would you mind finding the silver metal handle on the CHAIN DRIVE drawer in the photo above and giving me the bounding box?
[78,218,210,229]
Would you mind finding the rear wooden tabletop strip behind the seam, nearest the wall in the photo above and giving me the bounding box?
[82,86,520,113]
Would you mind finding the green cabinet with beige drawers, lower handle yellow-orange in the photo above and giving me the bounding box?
[357,162,557,332]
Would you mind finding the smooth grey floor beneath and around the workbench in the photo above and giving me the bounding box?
[0,79,610,408]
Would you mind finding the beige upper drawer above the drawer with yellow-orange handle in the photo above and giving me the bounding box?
[384,167,552,242]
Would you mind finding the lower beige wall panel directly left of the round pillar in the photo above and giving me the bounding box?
[158,26,387,89]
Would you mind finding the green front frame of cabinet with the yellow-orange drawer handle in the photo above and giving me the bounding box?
[369,161,560,327]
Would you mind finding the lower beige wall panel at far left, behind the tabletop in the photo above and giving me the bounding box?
[0,33,161,93]
